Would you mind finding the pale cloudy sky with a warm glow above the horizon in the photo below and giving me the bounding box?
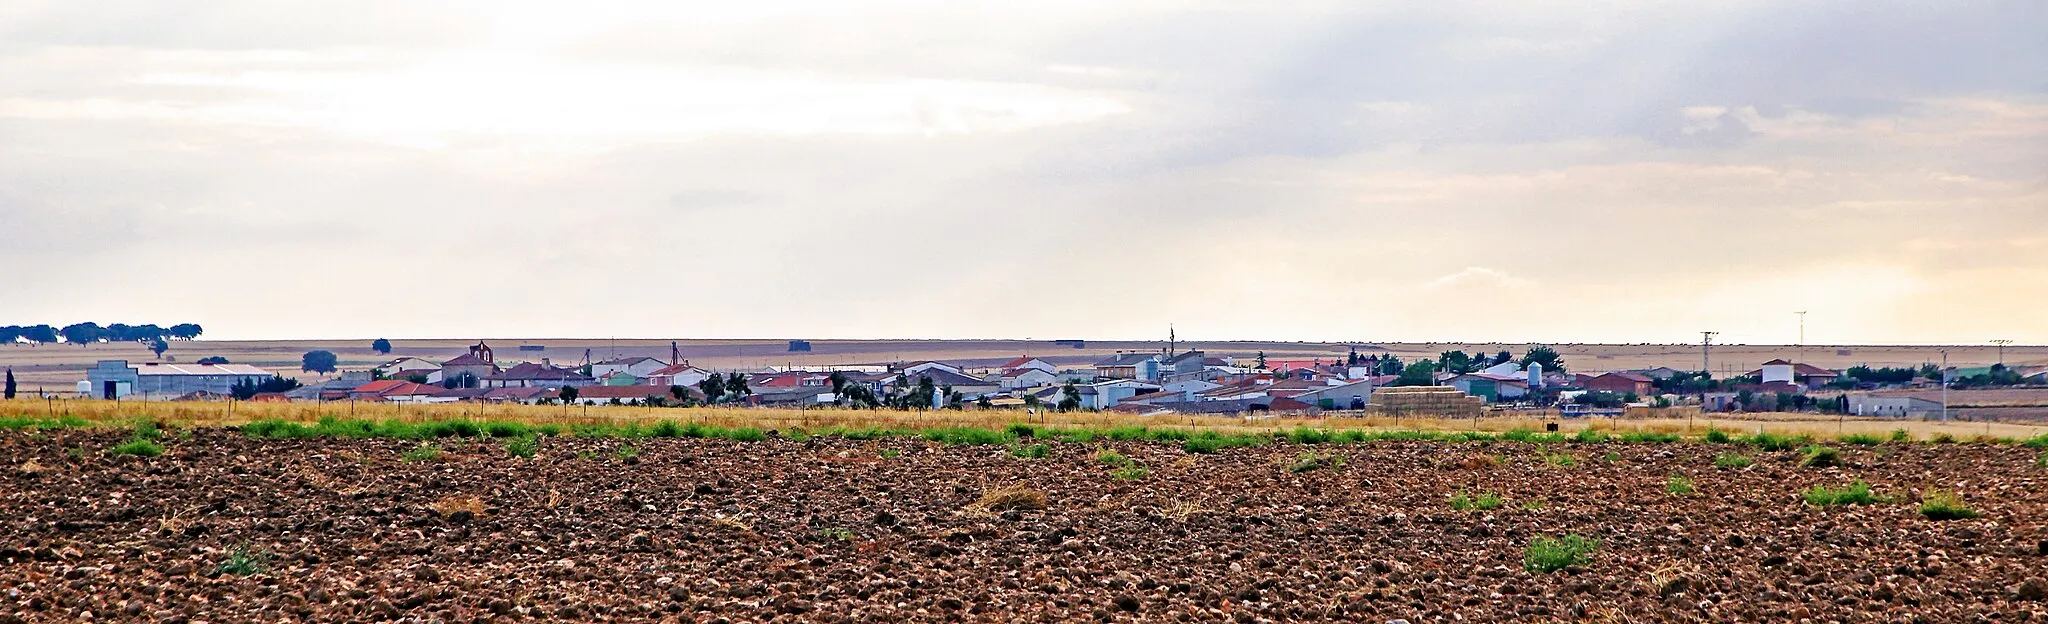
[0,0,2048,344]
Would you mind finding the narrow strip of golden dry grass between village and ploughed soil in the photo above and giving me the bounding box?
[0,399,2048,440]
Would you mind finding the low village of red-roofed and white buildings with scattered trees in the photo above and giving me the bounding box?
[59,340,2048,419]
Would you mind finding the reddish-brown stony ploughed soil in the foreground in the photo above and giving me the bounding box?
[0,430,2048,622]
